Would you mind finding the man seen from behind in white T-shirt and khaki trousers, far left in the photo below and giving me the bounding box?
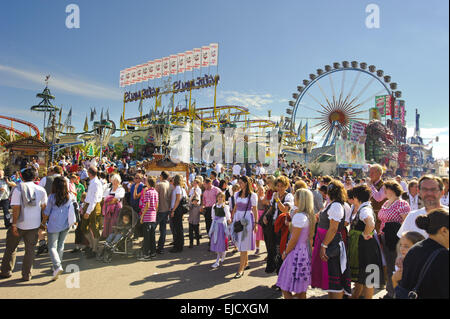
[0,168,47,281]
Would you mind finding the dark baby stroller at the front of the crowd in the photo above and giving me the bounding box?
[97,206,139,263]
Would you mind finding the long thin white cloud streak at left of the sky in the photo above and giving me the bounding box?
[0,64,122,100]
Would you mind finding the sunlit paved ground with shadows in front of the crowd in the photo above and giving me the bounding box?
[0,221,385,299]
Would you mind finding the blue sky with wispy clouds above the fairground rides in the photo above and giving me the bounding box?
[0,0,449,157]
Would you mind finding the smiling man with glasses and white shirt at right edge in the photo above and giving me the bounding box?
[397,175,448,238]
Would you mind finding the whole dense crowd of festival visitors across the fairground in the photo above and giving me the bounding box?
[0,154,449,299]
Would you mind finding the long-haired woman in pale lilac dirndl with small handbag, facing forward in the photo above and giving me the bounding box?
[230,176,258,279]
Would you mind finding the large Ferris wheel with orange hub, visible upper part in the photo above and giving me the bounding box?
[282,61,401,146]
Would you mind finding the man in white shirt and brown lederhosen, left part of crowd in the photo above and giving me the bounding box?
[81,166,103,258]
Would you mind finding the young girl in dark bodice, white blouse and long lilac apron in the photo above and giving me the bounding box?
[209,193,231,268]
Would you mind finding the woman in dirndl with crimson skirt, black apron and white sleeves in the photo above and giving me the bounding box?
[311,180,352,299]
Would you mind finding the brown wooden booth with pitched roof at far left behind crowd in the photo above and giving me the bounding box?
[4,136,50,177]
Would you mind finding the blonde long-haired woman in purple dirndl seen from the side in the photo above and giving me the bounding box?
[276,188,316,299]
